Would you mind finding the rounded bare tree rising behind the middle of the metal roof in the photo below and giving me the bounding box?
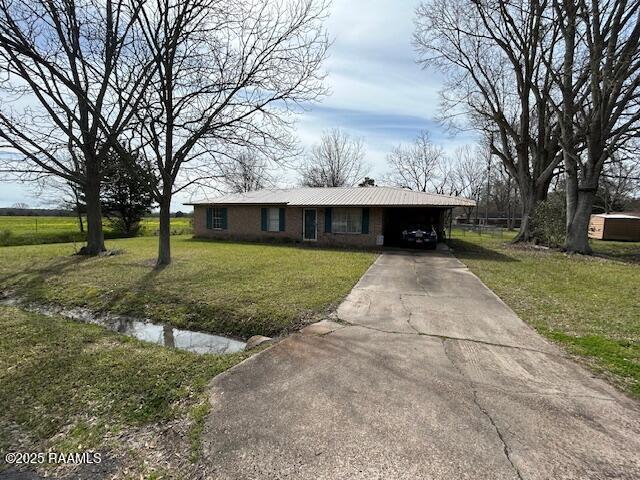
[300,128,369,187]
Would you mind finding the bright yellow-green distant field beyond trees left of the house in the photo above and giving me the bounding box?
[0,216,192,246]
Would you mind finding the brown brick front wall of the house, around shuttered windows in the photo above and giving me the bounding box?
[193,205,383,247]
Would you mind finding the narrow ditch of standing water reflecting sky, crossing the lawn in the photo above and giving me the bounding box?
[1,298,246,354]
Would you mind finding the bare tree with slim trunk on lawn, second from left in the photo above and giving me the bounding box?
[132,0,328,265]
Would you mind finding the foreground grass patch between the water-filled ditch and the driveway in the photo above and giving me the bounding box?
[0,306,249,471]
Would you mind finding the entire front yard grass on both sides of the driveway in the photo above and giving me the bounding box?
[0,233,640,478]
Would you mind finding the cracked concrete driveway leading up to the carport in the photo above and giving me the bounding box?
[199,252,640,480]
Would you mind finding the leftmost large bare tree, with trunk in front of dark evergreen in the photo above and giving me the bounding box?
[0,0,151,254]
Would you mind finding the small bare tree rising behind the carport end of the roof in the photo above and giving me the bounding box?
[387,131,445,192]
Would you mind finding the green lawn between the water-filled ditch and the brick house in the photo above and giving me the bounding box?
[0,236,376,338]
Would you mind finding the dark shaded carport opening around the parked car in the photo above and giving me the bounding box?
[382,206,451,247]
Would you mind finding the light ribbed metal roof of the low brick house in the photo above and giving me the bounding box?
[185,187,476,207]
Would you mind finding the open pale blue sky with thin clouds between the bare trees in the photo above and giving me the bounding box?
[0,0,471,209]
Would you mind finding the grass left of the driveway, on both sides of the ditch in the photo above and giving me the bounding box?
[0,236,376,478]
